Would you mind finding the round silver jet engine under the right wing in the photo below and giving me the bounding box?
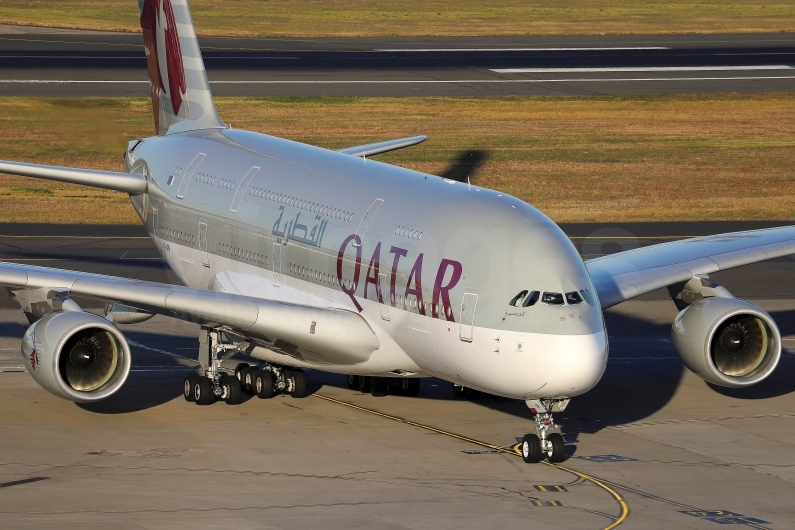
[671,298,781,388]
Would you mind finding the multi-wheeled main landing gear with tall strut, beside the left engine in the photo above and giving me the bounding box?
[182,328,306,405]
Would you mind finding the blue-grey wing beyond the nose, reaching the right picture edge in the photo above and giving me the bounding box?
[585,226,795,308]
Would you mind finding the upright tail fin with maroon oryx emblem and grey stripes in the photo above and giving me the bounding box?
[138,0,226,136]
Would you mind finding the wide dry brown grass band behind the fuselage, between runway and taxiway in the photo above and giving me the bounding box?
[0,94,795,223]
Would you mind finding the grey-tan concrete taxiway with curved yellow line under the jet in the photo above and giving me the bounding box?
[0,222,795,530]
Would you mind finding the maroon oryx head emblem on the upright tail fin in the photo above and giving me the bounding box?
[141,0,187,132]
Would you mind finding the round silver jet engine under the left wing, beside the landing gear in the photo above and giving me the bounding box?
[22,311,130,403]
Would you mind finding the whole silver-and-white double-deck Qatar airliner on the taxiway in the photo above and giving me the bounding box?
[0,0,795,462]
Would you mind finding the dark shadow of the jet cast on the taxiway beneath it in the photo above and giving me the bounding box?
[6,296,795,424]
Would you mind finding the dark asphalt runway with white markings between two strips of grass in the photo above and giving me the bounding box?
[0,26,795,96]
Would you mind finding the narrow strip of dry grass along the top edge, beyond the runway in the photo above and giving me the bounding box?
[0,0,795,37]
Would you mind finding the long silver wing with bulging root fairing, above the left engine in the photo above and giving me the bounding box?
[0,262,380,364]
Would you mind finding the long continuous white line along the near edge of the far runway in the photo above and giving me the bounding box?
[0,75,795,85]
